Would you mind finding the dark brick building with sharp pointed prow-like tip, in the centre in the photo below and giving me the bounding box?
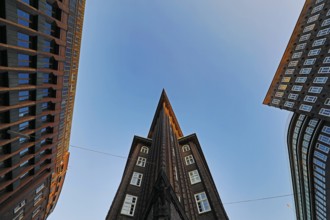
[106,91,228,220]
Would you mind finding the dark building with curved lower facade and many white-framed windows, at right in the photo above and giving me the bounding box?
[264,0,330,220]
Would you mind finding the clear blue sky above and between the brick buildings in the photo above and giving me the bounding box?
[48,0,304,220]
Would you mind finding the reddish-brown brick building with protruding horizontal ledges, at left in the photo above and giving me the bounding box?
[0,0,85,220]
